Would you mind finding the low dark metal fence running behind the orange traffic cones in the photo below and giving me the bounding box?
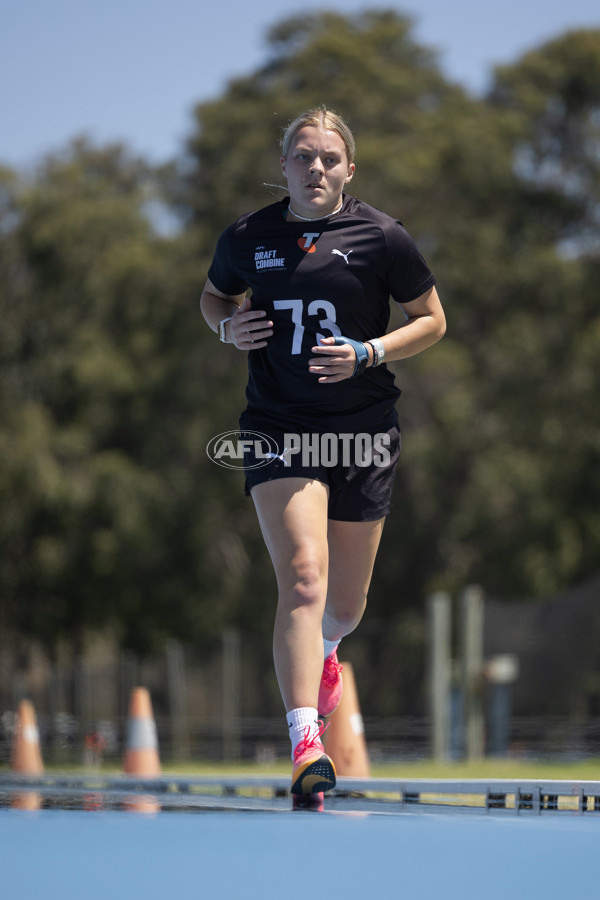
[0,710,600,768]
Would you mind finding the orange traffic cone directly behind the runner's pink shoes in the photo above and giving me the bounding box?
[324,663,370,778]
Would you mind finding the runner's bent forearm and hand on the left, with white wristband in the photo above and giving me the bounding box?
[200,279,273,350]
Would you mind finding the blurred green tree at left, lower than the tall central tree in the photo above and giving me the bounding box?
[0,142,272,651]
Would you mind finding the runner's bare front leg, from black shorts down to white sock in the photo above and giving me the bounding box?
[252,478,329,711]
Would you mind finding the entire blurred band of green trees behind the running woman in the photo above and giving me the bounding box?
[0,11,600,703]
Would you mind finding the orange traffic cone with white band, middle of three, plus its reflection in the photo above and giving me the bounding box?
[123,687,160,812]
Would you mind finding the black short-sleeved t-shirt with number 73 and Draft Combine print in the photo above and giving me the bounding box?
[208,196,435,432]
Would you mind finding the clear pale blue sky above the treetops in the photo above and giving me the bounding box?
[0,0,600,167]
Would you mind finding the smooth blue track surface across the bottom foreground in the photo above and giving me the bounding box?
[0,810,600,900]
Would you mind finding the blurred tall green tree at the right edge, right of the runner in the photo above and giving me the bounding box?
[436,31,600,596]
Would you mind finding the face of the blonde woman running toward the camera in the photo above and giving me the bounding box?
[281,125,354,218]
